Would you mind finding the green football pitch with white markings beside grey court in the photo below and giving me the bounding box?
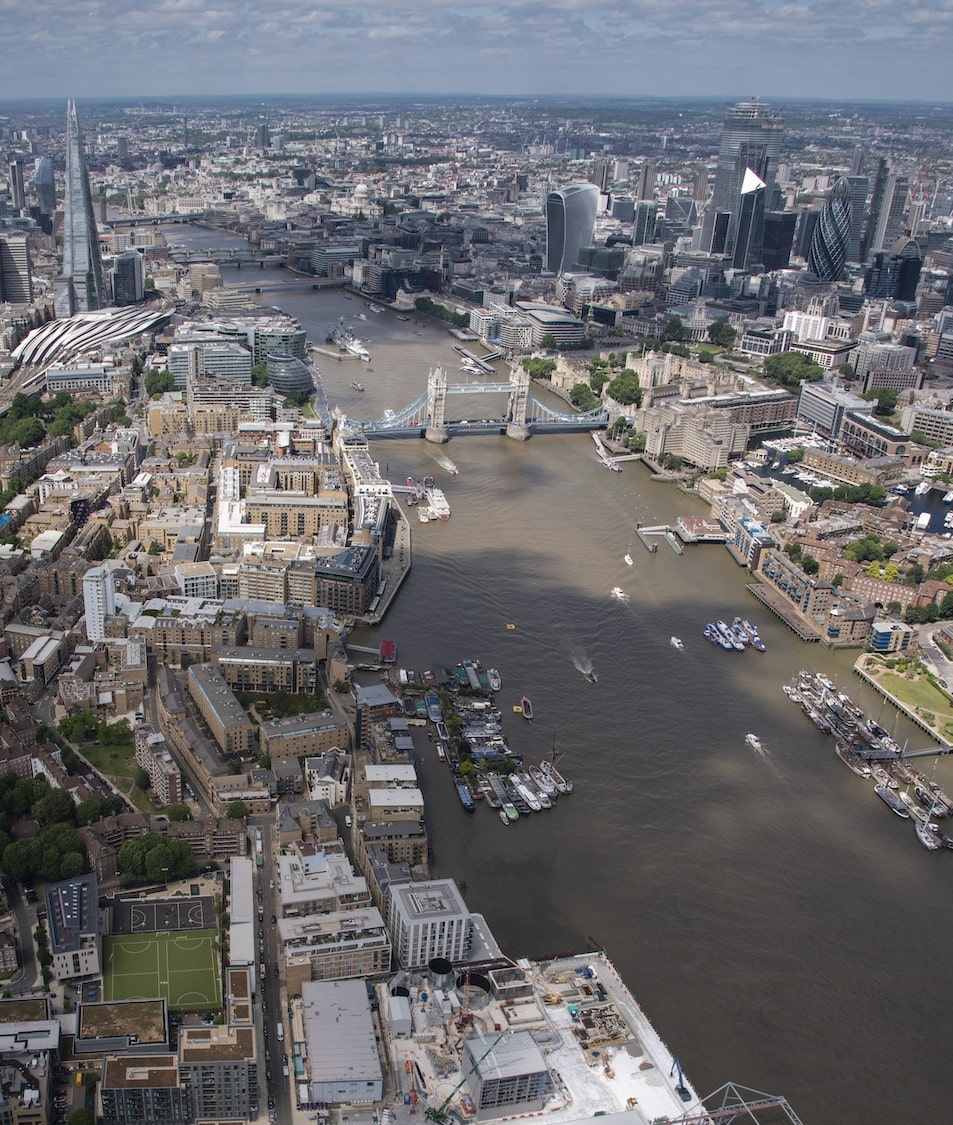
[104,929,222,1011]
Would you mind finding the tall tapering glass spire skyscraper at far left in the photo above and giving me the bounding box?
[63,98,107,313]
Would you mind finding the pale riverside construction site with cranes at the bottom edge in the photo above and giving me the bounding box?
[369,953,797,1125]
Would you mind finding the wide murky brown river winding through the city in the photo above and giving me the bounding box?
[165,226,953,1125]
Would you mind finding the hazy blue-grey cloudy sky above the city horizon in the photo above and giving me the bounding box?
[0,0,953,101]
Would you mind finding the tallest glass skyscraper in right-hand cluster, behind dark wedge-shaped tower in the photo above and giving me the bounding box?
[701,101,784,269]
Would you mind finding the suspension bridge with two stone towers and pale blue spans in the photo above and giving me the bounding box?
[348,367,609,444]
